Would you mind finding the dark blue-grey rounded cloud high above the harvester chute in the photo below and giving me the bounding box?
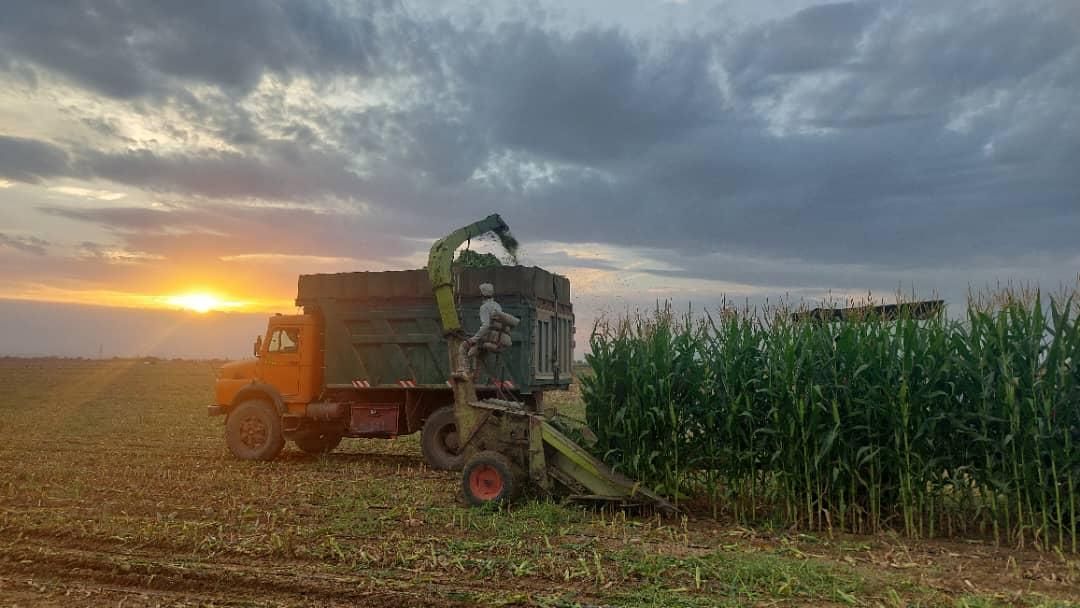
[455,23,723,164]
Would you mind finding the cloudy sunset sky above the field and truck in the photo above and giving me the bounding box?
[0,0,1080,356]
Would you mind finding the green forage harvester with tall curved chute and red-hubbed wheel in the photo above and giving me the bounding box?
[428,214,675,513]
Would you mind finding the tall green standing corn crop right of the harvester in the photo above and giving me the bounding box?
[582,291,1080,552]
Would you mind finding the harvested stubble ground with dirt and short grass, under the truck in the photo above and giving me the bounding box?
[0,359,1080,607]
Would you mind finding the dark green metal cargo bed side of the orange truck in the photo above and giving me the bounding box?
[296,267,573,393]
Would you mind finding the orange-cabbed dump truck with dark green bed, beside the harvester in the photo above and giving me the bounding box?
[208,235,575,470]
